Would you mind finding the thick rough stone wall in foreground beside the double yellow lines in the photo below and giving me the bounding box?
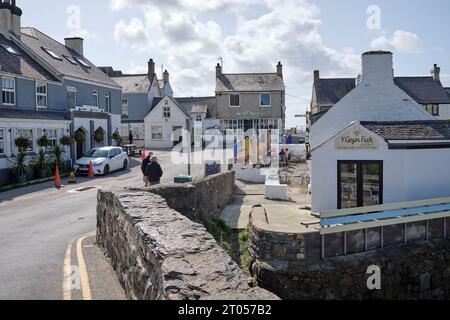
[97,184,278,300]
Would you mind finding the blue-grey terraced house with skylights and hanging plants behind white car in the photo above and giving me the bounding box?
[0,0,121,184]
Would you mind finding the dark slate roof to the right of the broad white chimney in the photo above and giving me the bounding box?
[394,77,450,104]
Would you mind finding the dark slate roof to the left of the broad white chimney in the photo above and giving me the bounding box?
[315,78,356,106]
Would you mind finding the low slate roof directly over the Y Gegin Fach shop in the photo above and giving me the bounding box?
[361,120,450,140]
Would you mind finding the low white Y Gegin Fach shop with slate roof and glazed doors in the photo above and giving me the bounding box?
[312,120,450,212]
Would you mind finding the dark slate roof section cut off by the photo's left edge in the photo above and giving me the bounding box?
[0,34,58,81]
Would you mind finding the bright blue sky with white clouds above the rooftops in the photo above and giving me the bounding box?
[17,0,450,127]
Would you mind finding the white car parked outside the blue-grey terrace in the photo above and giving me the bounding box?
[74,147,130,175]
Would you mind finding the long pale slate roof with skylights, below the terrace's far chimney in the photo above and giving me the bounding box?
[21,28,118,87]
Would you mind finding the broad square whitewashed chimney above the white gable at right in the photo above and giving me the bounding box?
[361,51,394,86]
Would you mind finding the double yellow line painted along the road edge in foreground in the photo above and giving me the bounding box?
[63,232,95,300]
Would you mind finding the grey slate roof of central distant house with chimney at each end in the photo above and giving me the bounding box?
[216,73,285,92]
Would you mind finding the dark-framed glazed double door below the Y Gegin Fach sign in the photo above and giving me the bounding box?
[338,161,383,209]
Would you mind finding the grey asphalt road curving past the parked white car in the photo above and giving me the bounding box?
[0,152,201,300]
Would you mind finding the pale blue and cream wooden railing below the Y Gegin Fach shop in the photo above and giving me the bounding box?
[320,198,450,258]
